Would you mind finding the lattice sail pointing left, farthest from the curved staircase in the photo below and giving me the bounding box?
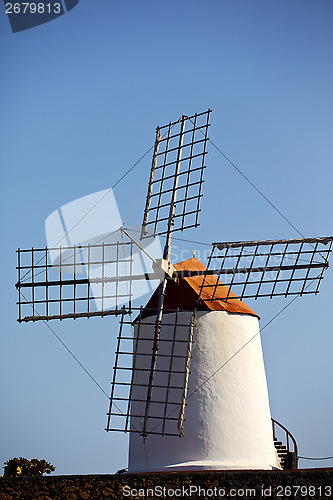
[16,241,133,322]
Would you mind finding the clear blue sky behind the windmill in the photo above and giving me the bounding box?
[0,0,333,474]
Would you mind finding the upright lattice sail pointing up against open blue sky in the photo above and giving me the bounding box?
[141,110,211,238]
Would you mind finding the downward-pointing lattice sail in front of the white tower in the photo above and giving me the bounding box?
[106,309,195,436]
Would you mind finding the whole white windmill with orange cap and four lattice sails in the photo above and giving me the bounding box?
[16,110,333,472]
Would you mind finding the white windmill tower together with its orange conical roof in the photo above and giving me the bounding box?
[129,258,278,472]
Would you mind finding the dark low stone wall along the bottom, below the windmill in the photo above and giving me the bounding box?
[0,468,333,500]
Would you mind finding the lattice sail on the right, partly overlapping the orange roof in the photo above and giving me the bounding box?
[200,237,333,301]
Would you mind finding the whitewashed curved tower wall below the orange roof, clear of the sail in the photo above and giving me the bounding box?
[129,311,277,472]
